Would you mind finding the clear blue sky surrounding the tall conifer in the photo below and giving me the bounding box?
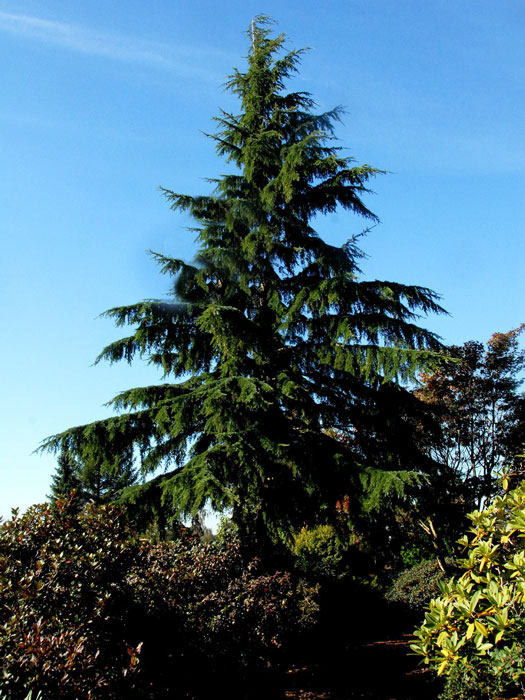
[0,0,525,516]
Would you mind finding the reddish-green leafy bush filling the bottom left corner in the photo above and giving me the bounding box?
[0,502,139,700]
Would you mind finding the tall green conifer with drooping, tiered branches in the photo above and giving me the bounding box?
[44,18,442,542]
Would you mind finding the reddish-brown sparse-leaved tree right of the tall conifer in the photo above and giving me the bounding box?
[416,324,525,510]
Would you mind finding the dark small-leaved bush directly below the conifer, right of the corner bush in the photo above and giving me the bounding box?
[126,536,318,695]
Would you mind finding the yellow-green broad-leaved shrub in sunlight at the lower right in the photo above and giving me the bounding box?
[411,476,525,697]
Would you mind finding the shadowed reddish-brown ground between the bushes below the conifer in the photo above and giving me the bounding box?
[266,581,443,700]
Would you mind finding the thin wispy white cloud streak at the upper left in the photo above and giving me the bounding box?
[0,12,229,84]
